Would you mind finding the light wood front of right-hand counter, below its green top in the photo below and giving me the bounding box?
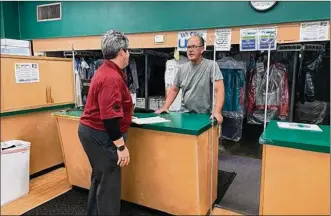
[260,145,330,215]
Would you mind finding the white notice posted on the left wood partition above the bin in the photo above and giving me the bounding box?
[15,63,39,83]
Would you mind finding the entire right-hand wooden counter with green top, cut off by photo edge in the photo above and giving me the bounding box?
[260,121,330,215]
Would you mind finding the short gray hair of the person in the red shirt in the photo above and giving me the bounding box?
[101,30,129,59]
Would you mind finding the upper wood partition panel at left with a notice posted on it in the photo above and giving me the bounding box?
[1,55,74,112]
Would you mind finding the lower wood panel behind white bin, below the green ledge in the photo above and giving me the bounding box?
[0,111,63,174]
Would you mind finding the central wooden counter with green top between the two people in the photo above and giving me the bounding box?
[53,111,219,215]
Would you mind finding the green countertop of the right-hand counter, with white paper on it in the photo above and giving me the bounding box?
[260,121,330,153]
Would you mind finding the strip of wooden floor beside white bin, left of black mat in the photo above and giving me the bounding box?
[1,168,71,215]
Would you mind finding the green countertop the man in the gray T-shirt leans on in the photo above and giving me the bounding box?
[53,110,215,135]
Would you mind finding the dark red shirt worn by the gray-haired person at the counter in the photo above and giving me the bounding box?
[80,60,133,133]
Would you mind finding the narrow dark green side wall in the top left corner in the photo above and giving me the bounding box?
[0,1,20,39]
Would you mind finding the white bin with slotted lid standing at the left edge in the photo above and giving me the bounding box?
[1,140,31,206]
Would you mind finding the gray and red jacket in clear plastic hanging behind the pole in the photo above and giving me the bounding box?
[247,63,289,124]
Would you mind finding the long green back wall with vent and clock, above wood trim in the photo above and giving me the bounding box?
[19,1,330,39]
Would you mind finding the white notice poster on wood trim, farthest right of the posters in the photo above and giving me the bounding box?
[300,21,329,41]
